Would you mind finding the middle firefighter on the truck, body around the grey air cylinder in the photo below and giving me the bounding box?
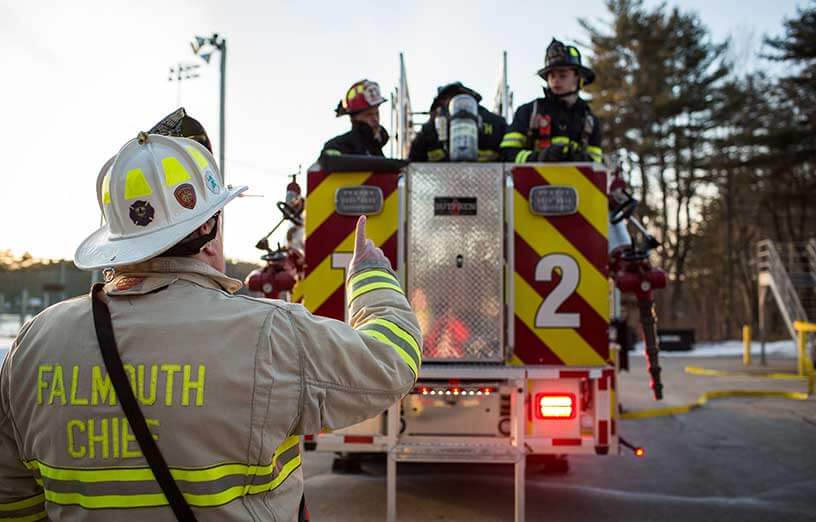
[408,82,507,161]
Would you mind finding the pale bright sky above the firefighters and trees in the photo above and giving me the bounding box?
[0,0,803,260]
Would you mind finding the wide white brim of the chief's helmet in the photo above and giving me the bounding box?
[74,186,248,270]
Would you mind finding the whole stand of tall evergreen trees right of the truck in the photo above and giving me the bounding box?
[581,0,816,339]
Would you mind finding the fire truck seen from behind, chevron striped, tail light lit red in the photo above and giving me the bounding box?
[250,53,665,521]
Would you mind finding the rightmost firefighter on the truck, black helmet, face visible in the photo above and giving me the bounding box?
[501,38,603,163]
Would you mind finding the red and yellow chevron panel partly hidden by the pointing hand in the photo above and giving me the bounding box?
[293,172,400,321]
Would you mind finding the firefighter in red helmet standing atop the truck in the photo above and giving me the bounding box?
[323,80,388,157]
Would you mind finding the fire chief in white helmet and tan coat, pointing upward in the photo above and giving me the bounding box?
[0,133,422,521]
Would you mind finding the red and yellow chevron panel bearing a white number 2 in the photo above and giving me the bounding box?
[512,165,609,366]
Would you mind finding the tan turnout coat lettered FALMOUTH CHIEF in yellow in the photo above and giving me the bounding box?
[0,258,422,521]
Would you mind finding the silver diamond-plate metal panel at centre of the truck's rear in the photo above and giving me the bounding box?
[407,163,504,362]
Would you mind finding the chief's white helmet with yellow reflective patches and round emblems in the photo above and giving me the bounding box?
[74,133,247,270]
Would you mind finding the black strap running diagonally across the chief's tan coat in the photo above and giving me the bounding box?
[91,283,196,522]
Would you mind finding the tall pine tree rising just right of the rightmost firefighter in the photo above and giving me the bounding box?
[581,0,729,318]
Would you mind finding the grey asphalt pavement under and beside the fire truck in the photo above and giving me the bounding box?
[304,357,816,522]
